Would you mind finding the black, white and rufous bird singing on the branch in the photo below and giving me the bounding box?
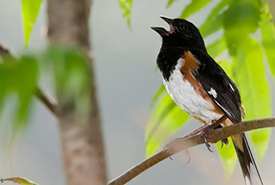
[151,16,263,185]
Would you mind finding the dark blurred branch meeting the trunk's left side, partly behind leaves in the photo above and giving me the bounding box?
[0,43,58,116]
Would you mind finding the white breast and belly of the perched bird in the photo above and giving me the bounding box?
[163,59,223,124]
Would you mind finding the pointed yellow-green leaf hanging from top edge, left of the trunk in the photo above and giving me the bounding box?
[21,0,43,46]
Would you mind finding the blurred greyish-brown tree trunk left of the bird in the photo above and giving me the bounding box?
[47,0,107,185]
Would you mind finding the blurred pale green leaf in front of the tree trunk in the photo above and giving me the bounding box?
[40,46,91,118]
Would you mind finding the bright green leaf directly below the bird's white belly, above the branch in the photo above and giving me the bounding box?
[145,94,189,156]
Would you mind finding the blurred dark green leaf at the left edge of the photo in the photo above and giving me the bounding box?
[0,56,38,131]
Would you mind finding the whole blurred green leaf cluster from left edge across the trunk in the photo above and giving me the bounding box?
[0,46,91,135]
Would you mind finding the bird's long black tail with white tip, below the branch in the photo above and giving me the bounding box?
[232,134,263,185]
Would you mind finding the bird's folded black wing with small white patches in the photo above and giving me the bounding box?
[190,50,242,123]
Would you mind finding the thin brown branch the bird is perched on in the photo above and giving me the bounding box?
[108,118,275,185]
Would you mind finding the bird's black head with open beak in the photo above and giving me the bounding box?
[152,16,206,51]
